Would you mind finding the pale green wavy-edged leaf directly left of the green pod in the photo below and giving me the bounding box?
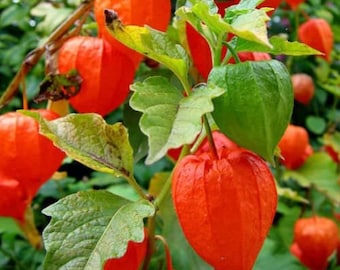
[130,76,223,164]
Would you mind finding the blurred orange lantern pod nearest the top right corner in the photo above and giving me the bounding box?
[298,18,334,61]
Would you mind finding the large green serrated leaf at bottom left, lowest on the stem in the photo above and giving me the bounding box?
[43,190,155,270]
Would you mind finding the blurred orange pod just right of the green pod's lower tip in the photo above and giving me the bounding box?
[278,125,313,170]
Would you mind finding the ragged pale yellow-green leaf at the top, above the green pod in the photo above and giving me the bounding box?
[176,2,271,47]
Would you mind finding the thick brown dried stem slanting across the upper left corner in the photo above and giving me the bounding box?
[0,0,94,108]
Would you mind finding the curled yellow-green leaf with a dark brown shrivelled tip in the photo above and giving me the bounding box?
[106,11,189,86]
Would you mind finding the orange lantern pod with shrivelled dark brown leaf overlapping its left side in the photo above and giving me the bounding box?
[58,36,135,116]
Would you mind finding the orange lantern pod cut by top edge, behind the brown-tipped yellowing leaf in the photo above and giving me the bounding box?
[94,0,171,67]
